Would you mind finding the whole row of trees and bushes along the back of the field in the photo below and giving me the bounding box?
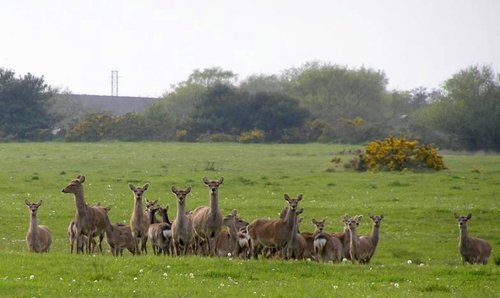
[0,62,500,150]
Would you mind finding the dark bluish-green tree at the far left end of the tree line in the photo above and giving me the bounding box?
[0,68,55,139]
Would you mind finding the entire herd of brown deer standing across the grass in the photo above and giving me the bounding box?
[25,176,491,264]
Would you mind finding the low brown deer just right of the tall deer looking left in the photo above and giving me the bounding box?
[104,207,136,256]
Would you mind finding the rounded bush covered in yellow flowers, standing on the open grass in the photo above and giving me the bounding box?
[352,137,446,171]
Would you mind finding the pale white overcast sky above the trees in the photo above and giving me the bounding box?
[0,0,500,96]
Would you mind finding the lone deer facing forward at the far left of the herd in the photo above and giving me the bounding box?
[24,199,52,253]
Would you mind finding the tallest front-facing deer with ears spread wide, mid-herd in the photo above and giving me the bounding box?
[191,177,224,256]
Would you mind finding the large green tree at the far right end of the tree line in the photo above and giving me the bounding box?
[421,65,500,150]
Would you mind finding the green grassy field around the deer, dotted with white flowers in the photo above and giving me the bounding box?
[0,143,500,297]
